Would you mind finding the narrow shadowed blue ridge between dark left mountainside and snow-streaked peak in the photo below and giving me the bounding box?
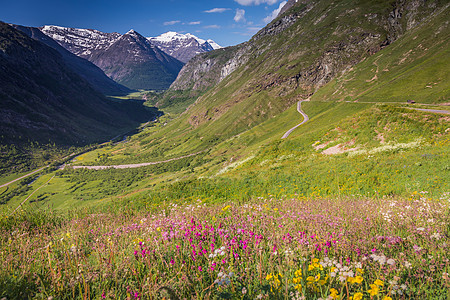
[13,25,131,95]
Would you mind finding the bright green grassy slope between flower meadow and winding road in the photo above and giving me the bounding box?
[1,102,450,210]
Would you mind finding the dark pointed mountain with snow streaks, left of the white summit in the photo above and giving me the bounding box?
[41,26,183,90]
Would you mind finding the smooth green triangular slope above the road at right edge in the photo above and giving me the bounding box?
[312,7,450,103]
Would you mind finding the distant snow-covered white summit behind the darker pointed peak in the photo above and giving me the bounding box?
[147,31,222,63]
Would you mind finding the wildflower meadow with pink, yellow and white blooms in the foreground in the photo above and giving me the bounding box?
[0,195,450,300]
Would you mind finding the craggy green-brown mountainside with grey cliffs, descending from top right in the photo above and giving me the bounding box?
[159,0,448,134]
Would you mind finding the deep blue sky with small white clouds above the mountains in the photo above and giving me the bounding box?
[0,0,285,46]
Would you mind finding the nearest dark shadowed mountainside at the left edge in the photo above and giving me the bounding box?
[0,23,152,145]
